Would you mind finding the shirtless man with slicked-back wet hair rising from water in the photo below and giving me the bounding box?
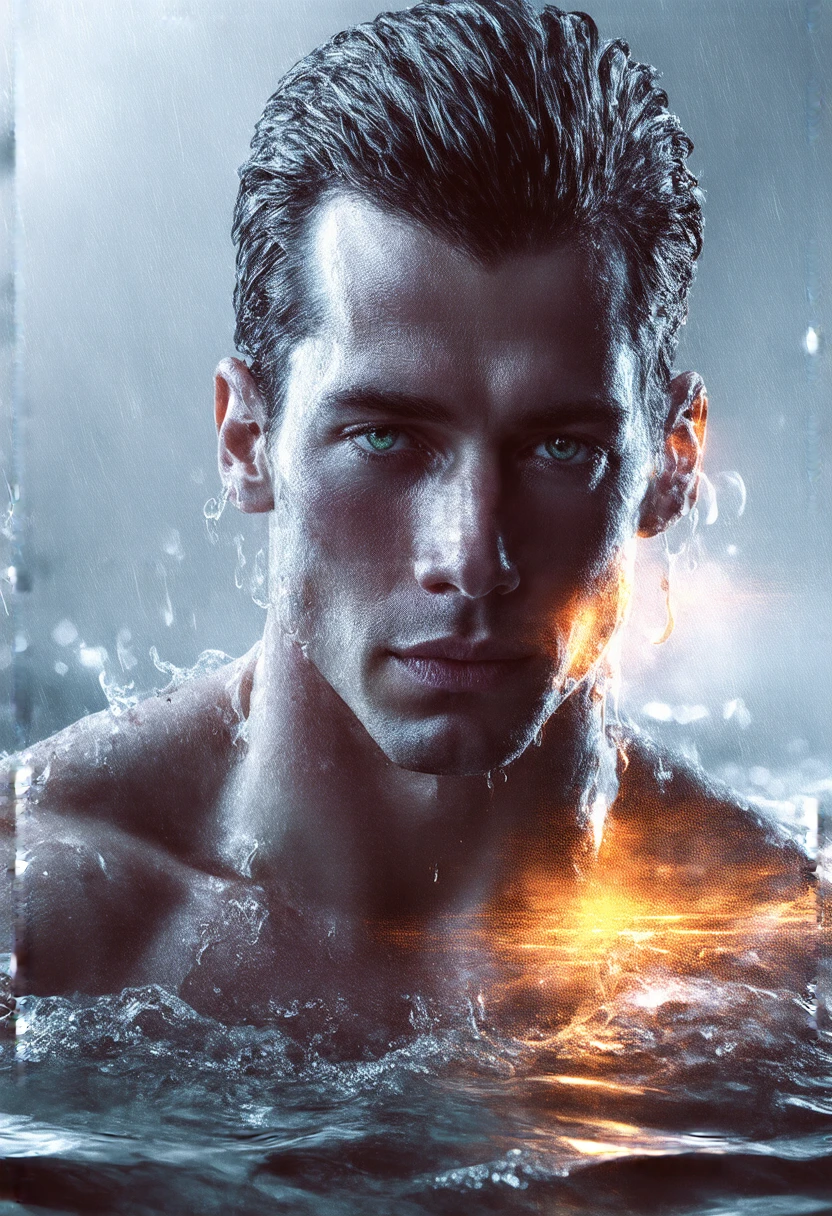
[6,0,811,1041]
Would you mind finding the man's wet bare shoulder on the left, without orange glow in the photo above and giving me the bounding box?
[15,652,253,861]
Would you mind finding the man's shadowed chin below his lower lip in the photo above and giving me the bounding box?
[370,719,543,777]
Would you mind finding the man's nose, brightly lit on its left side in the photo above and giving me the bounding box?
[415,456,519,599]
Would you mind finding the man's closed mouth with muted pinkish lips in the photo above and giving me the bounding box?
[390,637,534,692]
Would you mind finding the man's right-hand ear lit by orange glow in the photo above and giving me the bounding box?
[639,372,708,536]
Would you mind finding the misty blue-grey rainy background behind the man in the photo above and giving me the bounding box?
[0,0,832,795]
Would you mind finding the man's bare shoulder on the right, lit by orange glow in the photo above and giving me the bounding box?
[603,734,814,902]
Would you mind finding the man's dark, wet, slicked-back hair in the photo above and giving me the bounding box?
[232,0,702,423]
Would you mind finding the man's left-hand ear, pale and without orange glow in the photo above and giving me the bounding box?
[214,359,275,514]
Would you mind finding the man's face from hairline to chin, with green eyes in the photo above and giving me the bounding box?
[271,196,651,775]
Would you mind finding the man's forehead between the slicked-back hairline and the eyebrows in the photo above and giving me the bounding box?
[294,195,639,411]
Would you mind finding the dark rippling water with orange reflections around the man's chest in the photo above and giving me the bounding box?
[0,763,832,1216]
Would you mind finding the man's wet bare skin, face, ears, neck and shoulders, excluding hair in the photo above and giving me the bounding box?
[6,196,806,1024]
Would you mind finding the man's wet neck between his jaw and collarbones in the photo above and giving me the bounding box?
[224,619,615,921]
